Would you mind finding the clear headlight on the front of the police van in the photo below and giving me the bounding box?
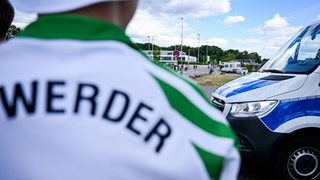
[230,101,277,117]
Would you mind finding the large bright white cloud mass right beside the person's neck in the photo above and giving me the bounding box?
[127,0,231,47]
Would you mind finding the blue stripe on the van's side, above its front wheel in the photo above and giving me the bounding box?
[261,97,320,131]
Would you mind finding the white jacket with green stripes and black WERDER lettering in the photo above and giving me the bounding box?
[0,15,240,180]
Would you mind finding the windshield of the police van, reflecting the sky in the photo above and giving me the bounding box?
[259,21,320,74]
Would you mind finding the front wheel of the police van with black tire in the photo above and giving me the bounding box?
[274,136,320,180]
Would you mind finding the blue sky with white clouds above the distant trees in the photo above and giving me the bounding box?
[14,0,320,58]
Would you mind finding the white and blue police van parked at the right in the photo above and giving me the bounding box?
[211,21,320,179]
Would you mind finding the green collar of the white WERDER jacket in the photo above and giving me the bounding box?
[18,14,139,49]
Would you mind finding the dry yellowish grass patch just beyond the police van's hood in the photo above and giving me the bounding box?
[195,74,240,86]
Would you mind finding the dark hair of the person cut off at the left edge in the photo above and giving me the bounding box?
[0,0,14,37]
